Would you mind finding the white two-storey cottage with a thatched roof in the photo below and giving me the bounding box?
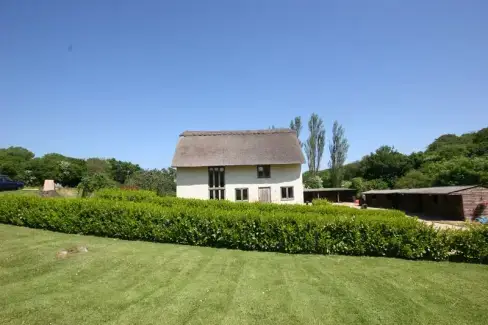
[172,129,305,203]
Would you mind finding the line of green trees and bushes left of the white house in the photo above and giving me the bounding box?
[0,147,176,195]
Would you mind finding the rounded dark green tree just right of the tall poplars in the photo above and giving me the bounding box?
[360,146,411,187]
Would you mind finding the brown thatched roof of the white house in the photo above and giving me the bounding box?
[172,129,305,167]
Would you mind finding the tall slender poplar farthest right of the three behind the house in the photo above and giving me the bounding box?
[329,121,349,187]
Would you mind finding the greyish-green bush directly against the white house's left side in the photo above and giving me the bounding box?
[126,167,176,196]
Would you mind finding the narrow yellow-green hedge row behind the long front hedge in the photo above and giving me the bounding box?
[95,189,406,219]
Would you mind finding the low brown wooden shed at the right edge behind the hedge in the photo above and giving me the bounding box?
[363,186,488,220]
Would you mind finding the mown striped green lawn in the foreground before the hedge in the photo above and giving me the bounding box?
[0,225,488,325]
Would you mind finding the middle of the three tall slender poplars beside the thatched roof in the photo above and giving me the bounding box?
[304,113,325,175]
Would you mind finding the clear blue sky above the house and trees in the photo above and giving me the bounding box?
[0,0,488,168]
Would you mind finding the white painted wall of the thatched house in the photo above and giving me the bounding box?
[176,164,303,203]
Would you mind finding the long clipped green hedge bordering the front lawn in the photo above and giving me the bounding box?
[0,195,488,263]
